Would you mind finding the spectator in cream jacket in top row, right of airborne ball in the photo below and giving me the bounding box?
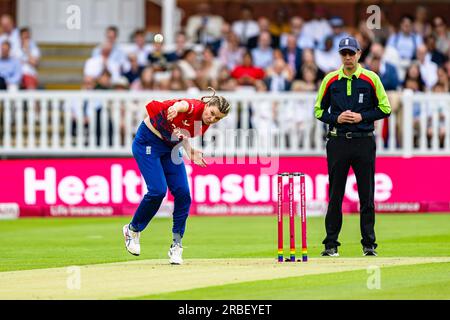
[186,3,223,45]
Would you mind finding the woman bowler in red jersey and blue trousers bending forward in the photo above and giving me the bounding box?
[123,88,230,264]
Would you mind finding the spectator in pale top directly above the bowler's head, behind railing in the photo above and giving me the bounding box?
[197,47,222,90]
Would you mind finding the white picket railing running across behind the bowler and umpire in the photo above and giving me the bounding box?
[0,91,450,157]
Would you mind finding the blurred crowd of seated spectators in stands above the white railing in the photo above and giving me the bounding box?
[0,3,450,148]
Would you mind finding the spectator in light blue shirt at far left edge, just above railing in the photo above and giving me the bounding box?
[0,40,22,90]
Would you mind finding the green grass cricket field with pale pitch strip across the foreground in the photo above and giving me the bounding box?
[0,214,450,299]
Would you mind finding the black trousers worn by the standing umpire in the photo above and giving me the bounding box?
[322,137,377,249]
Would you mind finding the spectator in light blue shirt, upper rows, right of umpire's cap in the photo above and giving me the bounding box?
[387,15,423,61]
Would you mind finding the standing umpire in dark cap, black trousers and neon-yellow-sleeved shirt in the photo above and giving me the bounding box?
[314,37,391,256]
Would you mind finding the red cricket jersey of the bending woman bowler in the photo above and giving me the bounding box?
[145,99,209,145]
